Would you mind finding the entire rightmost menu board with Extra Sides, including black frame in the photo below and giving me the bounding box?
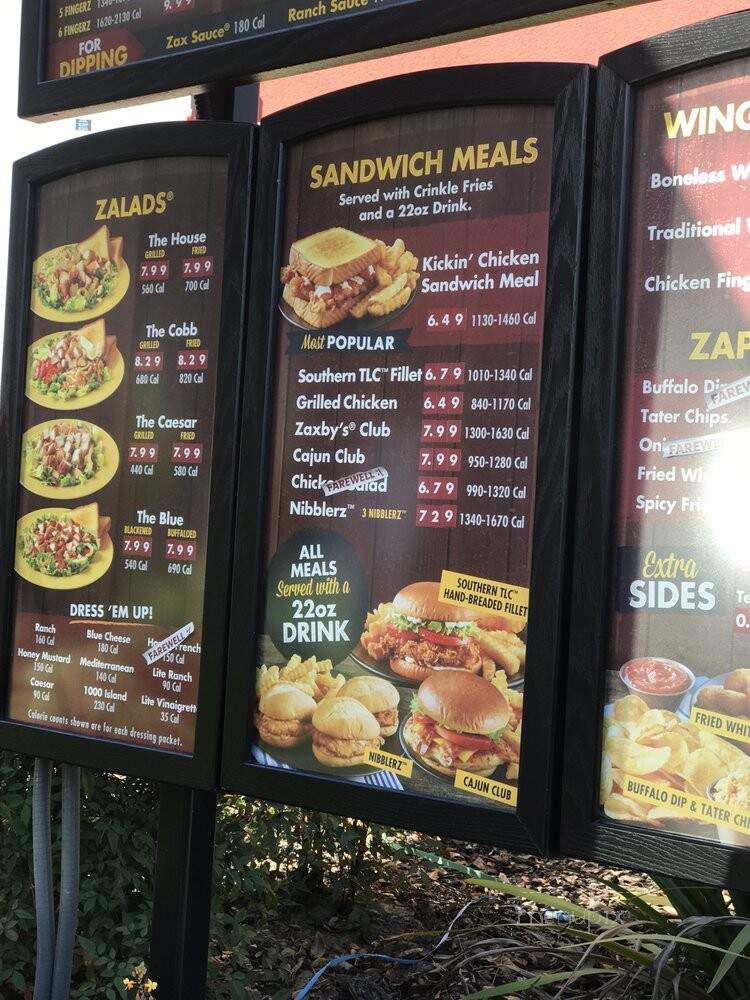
[562,13,750,888]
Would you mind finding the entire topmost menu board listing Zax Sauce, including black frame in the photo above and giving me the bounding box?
[19,0,644,120]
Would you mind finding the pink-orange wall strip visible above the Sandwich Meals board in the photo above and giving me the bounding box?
[260,0,748,116]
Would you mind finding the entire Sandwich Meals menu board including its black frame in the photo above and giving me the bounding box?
[223,65,588,851]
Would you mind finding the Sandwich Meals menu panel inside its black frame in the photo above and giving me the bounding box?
[251,105,553,809]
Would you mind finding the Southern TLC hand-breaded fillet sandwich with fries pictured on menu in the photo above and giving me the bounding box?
[360,581,526,683]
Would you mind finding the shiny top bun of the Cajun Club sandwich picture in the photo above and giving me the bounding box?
[417,670,511,736]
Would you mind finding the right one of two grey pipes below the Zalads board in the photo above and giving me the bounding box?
[51,764,81,1000]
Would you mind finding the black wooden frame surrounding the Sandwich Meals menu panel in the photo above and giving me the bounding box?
[222,63,591,853]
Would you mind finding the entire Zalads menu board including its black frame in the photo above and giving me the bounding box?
[0,125,254,784]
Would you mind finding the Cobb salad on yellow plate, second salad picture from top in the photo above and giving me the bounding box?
[27,319,124,409]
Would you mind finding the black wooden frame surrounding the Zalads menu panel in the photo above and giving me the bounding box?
[0,122,255,789]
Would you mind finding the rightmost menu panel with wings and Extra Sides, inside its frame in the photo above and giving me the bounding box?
[602,59,750,848]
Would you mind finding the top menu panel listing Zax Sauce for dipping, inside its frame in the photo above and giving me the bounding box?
[46,0,423,80]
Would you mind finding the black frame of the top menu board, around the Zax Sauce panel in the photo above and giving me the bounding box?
[18,0,643,120]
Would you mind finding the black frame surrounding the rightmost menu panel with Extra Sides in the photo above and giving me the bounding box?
[559,12,750,890]
